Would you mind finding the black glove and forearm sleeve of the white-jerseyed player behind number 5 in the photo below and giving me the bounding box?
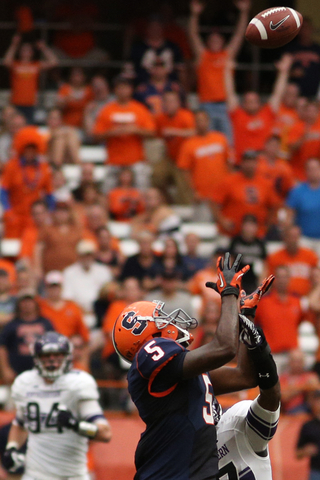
[239,315,279,390]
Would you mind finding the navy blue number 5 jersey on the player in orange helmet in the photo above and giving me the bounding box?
[128,338,218,480]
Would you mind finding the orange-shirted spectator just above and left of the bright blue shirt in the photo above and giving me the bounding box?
[258,135,294,200]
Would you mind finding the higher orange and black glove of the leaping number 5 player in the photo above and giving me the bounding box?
[206,252,250,298]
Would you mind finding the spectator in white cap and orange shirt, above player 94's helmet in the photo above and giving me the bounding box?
[38,270,89,343]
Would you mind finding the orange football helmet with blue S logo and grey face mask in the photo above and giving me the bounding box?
[112,301,197,362]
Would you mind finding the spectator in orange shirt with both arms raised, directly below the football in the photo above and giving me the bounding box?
[225,55,292,163]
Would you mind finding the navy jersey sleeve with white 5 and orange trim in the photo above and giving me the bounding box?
[136,338,187,396]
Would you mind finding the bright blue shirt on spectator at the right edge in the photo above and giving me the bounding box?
[287,183,320,238]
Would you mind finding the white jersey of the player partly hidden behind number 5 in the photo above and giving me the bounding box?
[217,399,280,480]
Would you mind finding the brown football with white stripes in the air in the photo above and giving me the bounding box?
[246,7,303,48]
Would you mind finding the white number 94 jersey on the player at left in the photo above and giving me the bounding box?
[12,369,103,480]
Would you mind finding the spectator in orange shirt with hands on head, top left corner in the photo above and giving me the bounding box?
[3,35,58,123]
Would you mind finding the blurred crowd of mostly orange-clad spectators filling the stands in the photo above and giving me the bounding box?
[0,0,320,420]
